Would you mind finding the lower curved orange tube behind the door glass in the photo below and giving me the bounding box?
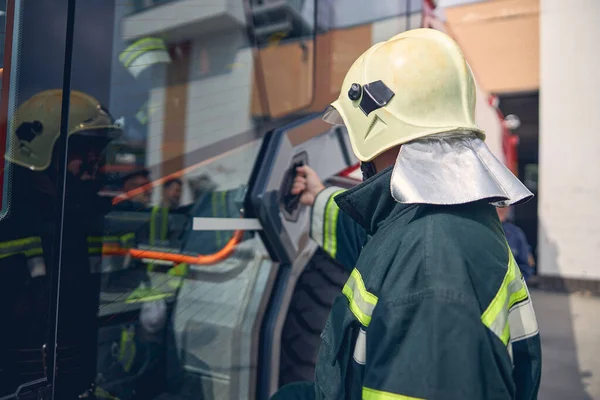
[102,231,244,265]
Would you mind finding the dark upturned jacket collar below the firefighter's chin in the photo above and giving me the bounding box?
[335,166,416,235]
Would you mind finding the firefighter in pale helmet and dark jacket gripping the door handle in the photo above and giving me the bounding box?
[274,29,541,400]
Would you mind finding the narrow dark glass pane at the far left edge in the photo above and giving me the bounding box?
[0,0,72,398]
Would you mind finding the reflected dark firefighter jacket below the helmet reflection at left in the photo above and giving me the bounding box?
[0,167,134,399]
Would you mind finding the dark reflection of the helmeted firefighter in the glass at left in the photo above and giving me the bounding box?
[0,90,122,400]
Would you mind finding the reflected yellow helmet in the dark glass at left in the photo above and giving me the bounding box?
[6,89,122,171]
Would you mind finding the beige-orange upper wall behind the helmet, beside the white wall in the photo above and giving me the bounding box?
[444,0,540,93]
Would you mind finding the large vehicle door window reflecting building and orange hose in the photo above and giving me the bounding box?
[56,0,276,400]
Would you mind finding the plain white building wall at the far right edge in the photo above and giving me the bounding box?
[538,0,600,279]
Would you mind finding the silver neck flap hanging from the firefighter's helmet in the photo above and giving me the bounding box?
[391,132,533,207]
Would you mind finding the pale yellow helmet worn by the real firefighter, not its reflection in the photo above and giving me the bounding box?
[323,29,485,162]
